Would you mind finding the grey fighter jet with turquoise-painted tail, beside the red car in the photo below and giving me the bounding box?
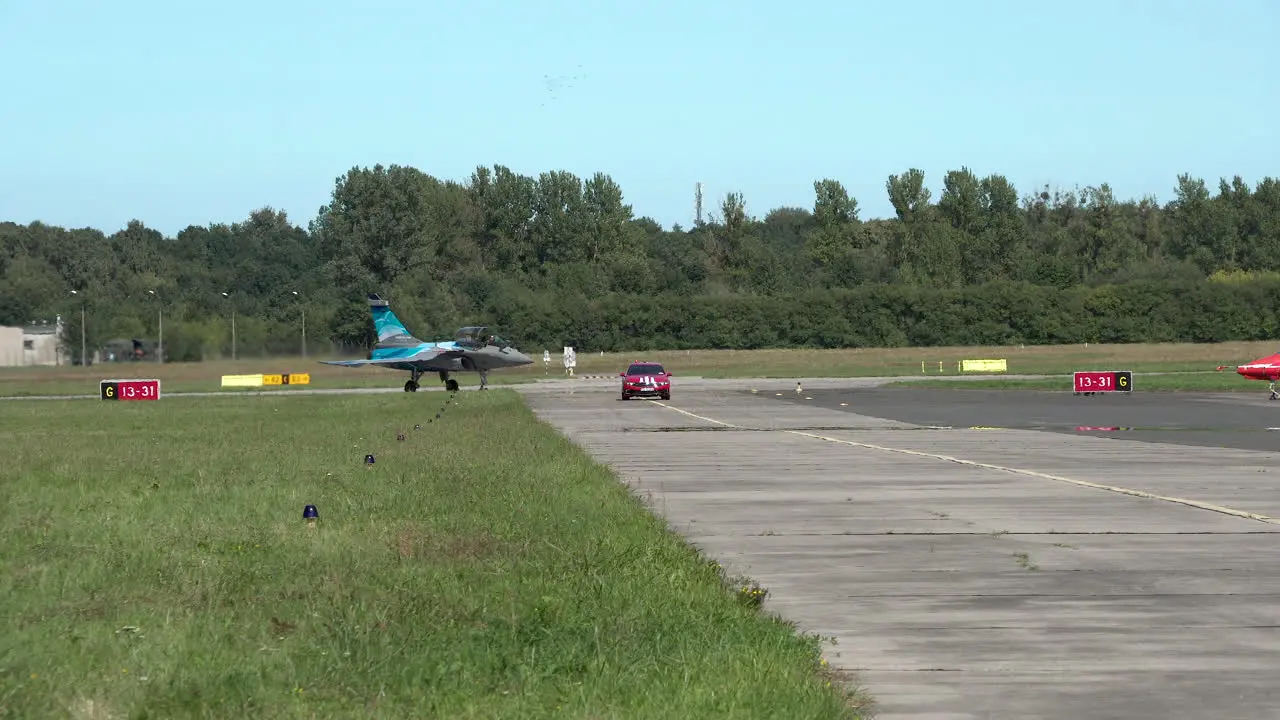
[321,293,532,392]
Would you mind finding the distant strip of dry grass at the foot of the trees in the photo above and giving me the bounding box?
[0,342,1275,396]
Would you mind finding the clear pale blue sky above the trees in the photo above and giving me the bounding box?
[0,0,1280,234]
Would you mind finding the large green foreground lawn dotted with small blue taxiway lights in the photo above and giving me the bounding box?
[0,389,859,719]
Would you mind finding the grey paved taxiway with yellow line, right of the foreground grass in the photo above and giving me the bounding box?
[517,380,1280,720]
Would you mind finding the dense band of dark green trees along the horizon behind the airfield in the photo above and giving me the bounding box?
[0,165,1280,361]
